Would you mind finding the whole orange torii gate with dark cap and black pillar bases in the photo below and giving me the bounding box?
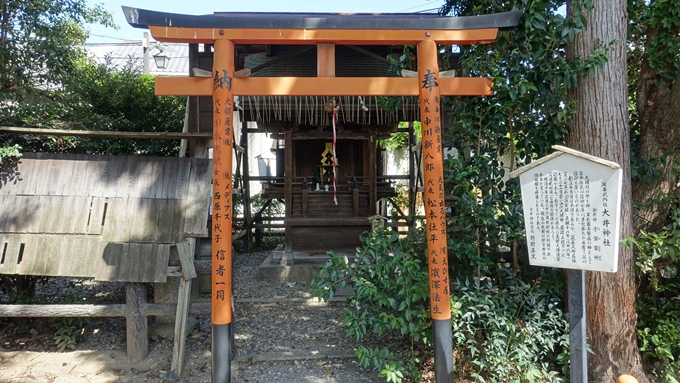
[123,7,522,383]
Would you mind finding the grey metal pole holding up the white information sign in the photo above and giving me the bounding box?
[566,269,588,383]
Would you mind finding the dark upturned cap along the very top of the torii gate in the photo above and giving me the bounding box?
[122,6,523,30]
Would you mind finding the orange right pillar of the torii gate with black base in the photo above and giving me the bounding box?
[418,40,453,383]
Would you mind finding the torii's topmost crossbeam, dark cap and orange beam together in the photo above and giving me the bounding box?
[123,7,522,45]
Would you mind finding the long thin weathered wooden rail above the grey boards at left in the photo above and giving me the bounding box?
[0,126,212,140]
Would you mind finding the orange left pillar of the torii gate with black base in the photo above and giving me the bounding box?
[212,40,234,383]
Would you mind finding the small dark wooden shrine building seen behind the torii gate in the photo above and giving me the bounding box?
[189,39,422,263]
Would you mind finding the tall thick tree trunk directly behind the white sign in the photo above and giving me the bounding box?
[566,0,648,383]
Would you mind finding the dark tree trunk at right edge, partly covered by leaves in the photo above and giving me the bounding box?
[633,28,680,233]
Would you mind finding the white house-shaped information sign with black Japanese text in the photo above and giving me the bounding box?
[511,146,622,272]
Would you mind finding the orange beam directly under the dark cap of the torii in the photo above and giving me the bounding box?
[149,26,498,45]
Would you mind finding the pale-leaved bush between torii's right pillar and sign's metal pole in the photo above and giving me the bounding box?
[451,272,569,382]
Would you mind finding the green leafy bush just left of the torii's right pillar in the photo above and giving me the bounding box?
[312,229,431,382]
